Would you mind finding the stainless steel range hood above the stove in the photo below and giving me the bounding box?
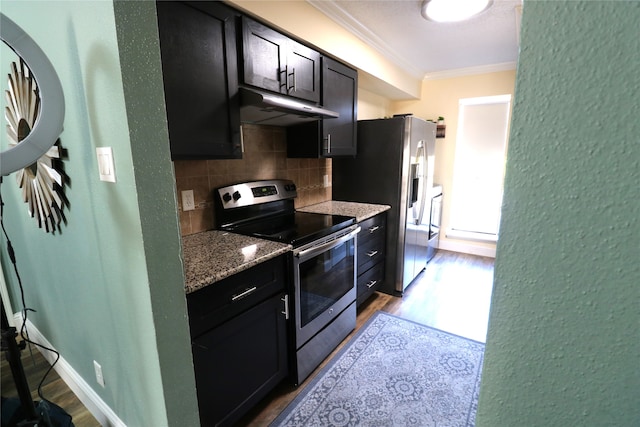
[239,87,340,126]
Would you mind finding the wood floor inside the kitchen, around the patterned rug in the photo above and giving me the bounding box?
[238,251,493,427]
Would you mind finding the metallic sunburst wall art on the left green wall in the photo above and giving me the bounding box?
[4,59,64,233]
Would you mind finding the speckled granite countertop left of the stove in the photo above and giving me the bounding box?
[182,230,292,294]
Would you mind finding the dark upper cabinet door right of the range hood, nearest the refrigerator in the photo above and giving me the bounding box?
[322,58,358,157]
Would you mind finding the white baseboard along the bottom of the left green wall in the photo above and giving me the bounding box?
[13,313,126,427]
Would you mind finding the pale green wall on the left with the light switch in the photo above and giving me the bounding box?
[0,1,198,426]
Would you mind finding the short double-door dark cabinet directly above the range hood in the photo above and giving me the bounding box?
[241,16,320,103]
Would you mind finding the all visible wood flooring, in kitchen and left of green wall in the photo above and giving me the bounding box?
[1,251,493,427]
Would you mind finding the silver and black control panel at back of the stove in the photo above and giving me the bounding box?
[214,179,298,209]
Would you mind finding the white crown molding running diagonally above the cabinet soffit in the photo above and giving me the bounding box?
[306,0,424,79]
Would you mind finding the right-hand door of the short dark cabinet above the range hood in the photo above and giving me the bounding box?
[286,40,320,103]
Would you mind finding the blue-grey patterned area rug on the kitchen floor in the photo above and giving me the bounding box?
[271,312,484,427]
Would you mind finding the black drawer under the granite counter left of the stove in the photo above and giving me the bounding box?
[187,254,287,337]
